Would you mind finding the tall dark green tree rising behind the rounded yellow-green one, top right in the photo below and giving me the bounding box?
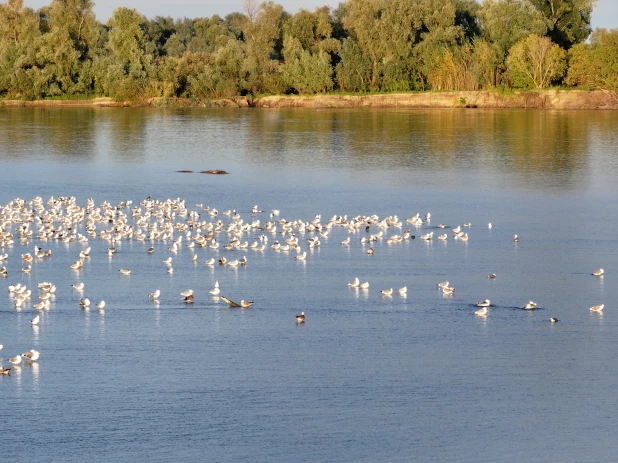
[530,0,596,50]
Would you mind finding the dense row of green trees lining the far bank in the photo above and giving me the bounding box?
[0,0,618,104]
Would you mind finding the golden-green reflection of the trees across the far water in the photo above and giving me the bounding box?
[0,108,617,192]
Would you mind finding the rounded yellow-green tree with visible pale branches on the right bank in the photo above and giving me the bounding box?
[506,34,566,88]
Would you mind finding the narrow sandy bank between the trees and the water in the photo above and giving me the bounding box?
[0,90,618,109]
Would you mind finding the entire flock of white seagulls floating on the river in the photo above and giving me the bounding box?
[0,197,604,375]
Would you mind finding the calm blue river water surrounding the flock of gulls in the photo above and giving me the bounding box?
[0,108,618,462]
